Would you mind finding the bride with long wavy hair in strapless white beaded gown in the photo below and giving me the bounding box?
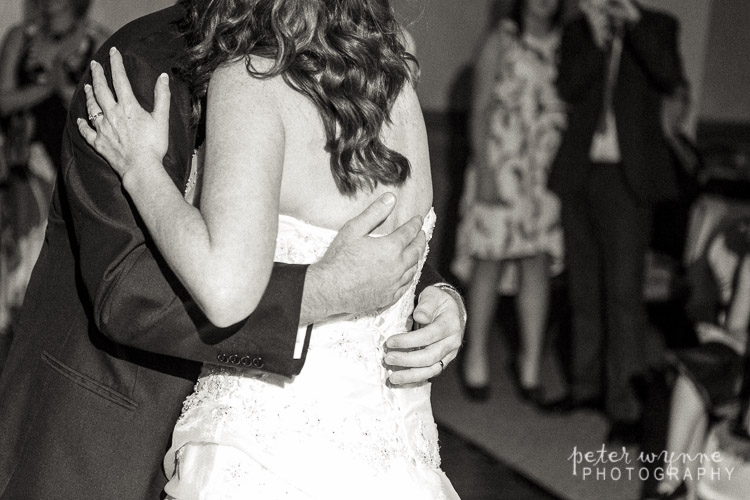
[79,0,458,500]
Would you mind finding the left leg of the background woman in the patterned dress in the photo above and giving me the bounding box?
[462,260,502,387]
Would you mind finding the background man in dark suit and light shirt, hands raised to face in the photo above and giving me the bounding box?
[549,0,683,441]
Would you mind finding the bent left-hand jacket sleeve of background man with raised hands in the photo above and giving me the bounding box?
[557,17,606,103]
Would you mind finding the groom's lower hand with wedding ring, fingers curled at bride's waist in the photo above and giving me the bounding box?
[385,286,466,385]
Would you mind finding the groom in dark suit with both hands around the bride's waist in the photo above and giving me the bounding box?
[0,1,464,500]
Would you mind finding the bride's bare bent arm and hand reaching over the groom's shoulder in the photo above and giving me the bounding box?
[78,47,284,326]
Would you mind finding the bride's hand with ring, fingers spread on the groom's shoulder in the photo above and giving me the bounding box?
[76,47,170,181]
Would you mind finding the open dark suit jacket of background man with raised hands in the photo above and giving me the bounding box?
[549,8,683,203]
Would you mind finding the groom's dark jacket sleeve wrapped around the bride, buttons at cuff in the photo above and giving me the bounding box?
[61,46,306,376]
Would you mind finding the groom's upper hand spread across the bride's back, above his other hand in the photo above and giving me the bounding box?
[300,193,427,324]
